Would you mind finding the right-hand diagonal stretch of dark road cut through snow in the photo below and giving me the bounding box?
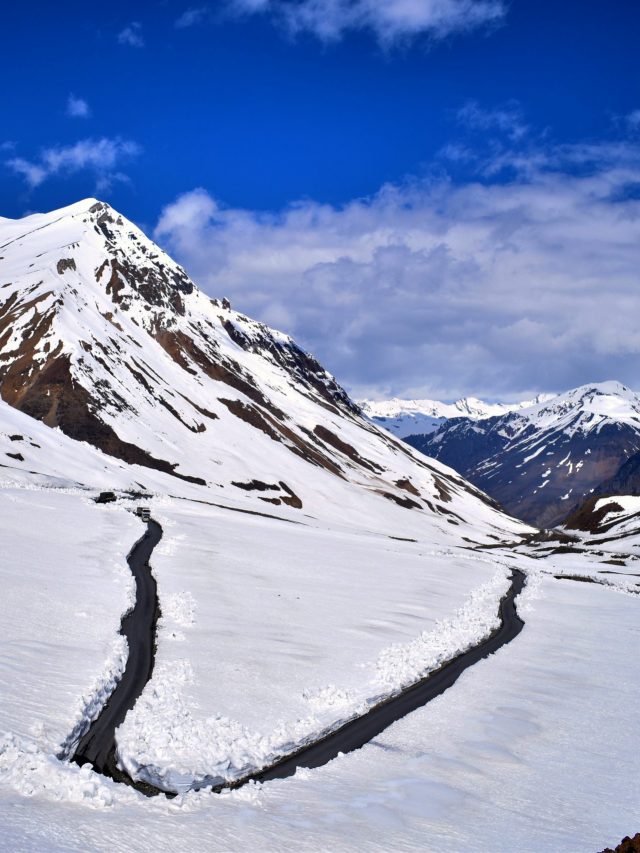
[225,569,526,791]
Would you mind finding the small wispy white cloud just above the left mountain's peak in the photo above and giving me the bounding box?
[6,138,140,190]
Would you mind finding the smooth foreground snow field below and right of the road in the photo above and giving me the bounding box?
[0,575,640,853]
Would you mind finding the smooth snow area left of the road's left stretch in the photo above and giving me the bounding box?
[0,489,143,755]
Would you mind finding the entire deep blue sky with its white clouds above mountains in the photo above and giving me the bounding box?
[0,0,640,398]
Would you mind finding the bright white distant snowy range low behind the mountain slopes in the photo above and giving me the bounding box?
[360,394,554,438]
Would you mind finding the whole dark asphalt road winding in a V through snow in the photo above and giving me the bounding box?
[72,521,526,796]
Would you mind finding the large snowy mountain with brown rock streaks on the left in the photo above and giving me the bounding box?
[0,199,524,527]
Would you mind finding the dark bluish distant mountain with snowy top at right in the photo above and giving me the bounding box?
[407,382,640,526]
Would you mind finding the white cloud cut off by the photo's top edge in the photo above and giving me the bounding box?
[228,0,506,46]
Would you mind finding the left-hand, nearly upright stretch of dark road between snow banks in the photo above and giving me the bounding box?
[72,521,162,787]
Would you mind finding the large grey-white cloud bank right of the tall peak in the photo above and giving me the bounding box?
[155,136,640,398]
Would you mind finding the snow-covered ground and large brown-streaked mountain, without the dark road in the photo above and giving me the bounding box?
[0,200,640,851]
